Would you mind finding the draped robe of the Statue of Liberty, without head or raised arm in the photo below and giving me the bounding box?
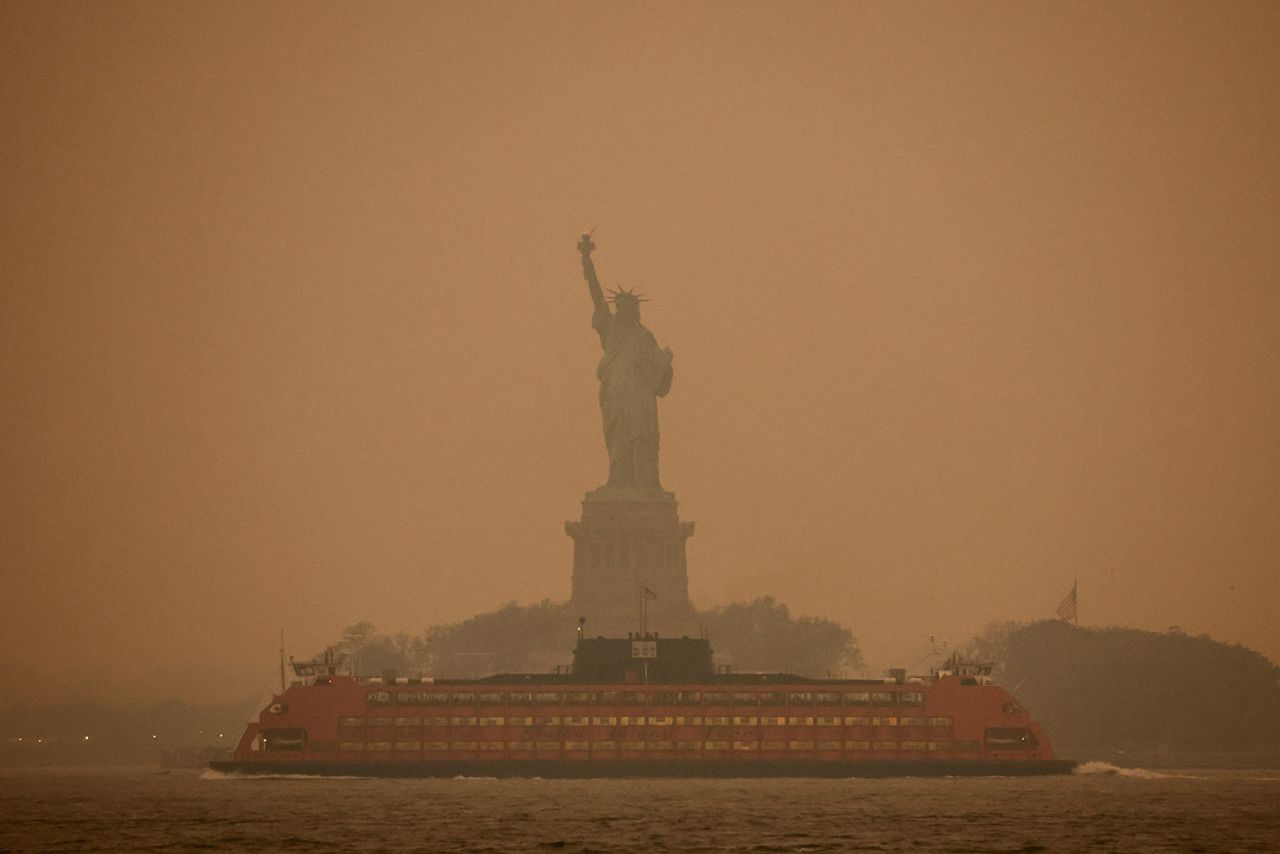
[591,306,672,488]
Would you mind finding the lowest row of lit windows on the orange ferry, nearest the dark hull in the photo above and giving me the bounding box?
[338,740,982,753]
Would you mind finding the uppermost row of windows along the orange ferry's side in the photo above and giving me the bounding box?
[366,690,924,707]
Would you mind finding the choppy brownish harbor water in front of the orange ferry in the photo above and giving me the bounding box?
[0,763,1280,851]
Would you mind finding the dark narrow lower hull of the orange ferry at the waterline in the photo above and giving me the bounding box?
[210,759,1076,778]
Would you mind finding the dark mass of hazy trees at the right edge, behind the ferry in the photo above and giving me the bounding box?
[972,621,1280,757]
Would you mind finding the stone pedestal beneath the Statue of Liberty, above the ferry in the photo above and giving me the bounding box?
[564,487,698,636]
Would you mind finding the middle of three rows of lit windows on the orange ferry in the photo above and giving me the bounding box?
[339,714,951,727]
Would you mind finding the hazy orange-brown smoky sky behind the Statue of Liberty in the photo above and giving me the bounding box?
[0,1,1280,699]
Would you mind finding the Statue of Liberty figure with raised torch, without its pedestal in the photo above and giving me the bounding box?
[577,234,672,497]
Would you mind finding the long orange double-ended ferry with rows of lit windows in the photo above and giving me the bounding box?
[210,634,1075,777]
